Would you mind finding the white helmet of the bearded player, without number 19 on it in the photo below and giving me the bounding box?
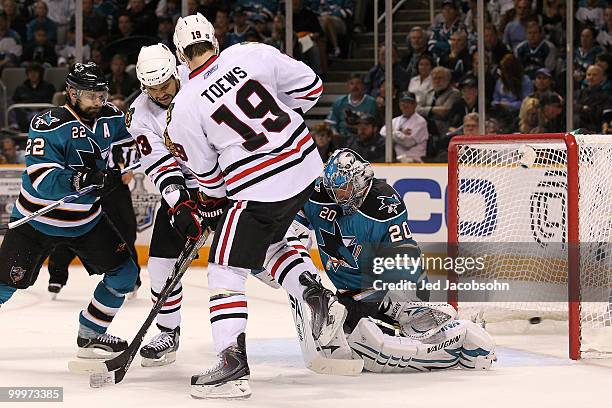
[136,43,179,87]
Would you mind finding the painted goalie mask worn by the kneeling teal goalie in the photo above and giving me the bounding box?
[323,149,374,215]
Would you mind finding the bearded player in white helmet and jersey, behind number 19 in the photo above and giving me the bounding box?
[126,43,203,367]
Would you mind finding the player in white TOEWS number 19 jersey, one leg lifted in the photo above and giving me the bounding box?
[165,14,346,398]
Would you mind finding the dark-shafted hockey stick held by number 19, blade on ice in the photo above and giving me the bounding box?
[68,229,210,388]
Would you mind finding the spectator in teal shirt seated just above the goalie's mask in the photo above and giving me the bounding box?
[325,74,377,147]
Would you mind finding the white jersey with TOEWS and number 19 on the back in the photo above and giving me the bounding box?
[167,43,323,202]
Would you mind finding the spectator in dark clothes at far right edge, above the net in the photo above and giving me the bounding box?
[574,65,612,132]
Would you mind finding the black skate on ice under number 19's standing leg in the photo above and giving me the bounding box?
[191,333,251,398]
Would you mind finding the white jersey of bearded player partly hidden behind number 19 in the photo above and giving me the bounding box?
[125,65,223,206]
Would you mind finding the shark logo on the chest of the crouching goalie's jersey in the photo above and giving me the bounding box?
[319,221,362,272]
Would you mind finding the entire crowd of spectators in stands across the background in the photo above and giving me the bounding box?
[0,0,612,162]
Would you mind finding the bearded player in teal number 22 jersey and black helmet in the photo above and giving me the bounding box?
[0,63,138,358]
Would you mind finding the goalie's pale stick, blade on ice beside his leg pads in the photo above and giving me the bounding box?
[289,295,363,375]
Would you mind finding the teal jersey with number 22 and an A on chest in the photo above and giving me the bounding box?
[11,103,133,237]
